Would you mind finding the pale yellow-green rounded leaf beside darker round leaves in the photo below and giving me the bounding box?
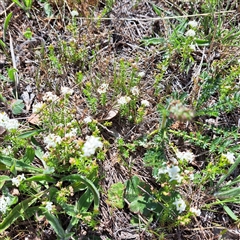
[107,182,125,209]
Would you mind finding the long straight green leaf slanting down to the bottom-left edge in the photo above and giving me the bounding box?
[0,192,43,233]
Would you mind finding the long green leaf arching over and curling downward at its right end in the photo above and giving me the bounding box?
[61,174,100,212]
